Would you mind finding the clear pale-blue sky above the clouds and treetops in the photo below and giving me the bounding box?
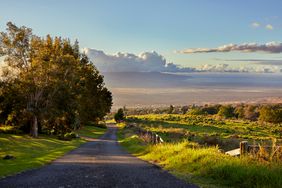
[0,0,282,69]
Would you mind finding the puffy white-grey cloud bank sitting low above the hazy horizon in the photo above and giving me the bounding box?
[83,48,282,73]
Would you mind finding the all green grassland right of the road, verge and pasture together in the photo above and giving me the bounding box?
[119,114,282,187]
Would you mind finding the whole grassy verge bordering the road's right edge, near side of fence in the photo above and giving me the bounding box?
[118,123,282,187]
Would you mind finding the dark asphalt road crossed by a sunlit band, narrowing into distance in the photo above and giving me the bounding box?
[0,124,196,188]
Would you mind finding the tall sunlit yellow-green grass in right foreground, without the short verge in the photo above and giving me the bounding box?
[142,141,282,187]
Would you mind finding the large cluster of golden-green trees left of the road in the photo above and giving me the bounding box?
[0,22,112,137]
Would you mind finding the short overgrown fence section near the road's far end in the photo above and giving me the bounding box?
[126,123,164,144]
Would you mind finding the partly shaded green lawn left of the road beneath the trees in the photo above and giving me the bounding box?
[0,126,106,178]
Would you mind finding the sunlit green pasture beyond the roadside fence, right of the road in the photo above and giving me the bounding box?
[127,114,282,150]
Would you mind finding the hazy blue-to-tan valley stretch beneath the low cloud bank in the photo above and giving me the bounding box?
[102,72,282,108]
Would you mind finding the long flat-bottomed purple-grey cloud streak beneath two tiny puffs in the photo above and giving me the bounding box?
[178,42,282,54]
